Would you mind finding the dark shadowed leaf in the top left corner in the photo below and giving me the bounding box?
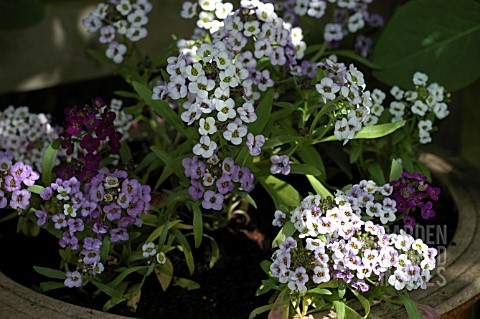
[0,0,44,30]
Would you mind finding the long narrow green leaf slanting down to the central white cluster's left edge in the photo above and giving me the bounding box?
[133,82,192,137]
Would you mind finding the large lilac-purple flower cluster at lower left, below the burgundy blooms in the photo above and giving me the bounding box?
[35,169,151,287]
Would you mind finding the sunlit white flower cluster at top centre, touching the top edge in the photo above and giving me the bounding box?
[181,0,306,62]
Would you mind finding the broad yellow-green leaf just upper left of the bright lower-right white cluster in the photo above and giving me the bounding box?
[258,175,302,209]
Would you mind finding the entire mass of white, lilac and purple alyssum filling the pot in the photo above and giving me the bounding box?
[0,0,470,318]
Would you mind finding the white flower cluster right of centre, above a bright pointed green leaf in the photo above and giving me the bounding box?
[315,57,372,145]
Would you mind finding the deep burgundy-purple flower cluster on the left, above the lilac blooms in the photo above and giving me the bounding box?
[57,98,123,181]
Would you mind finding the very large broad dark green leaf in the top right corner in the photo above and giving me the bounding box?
[373,0,480,91]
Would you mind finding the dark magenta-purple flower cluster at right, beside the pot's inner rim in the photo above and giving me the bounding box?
[390,172,441,230]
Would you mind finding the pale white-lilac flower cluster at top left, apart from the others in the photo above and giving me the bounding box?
[82,0,152,64]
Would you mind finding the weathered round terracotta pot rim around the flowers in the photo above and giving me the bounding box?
[0,154,480,319]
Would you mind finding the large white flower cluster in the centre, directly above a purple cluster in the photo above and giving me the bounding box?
[153,42,265,159]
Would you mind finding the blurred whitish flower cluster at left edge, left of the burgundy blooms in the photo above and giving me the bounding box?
[0,105,61,172]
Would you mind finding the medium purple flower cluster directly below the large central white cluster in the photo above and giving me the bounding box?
[182,156,254,210]
